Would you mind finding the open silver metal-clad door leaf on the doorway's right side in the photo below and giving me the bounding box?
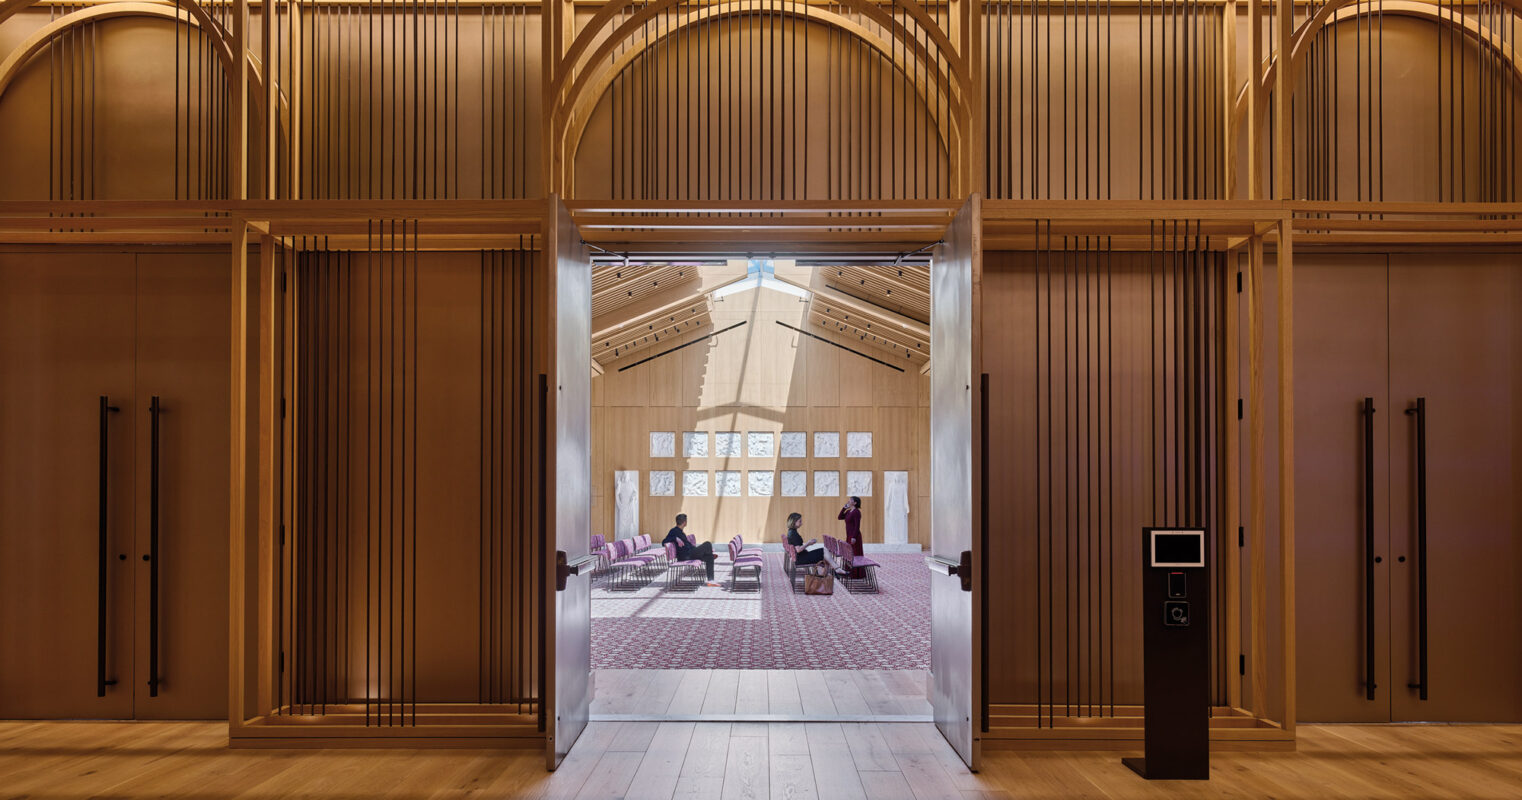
[925,195,983,770]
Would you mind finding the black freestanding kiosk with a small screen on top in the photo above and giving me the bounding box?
[1123,528,1210,780]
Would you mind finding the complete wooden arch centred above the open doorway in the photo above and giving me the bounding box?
[545,0,967,192]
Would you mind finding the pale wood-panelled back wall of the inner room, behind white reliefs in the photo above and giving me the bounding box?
[592,279,930,544]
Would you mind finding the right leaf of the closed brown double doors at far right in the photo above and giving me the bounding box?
[1388,254,1522,722]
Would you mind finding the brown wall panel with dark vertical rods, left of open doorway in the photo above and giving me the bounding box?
[269,244,543,727]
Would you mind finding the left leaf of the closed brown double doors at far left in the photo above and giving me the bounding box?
[0,252,142,719]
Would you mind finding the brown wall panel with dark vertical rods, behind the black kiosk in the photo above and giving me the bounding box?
[983,243,1236,714]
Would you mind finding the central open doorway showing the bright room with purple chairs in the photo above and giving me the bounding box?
[589,259,931,721]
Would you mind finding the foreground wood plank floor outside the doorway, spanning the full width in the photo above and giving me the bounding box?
[0,722,1522,800]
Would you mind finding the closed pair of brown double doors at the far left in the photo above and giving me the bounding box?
[0,249,231,719]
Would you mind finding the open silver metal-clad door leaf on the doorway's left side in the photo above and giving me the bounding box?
[540,196,592,770]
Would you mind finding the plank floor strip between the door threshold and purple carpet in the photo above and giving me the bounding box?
[592,669,931,722]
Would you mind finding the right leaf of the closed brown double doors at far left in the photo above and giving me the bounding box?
[131,252,230,719]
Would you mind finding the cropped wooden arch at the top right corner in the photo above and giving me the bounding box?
[1231,0,1522,129]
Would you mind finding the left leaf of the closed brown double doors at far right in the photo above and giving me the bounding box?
[1295,256,1400,722]
